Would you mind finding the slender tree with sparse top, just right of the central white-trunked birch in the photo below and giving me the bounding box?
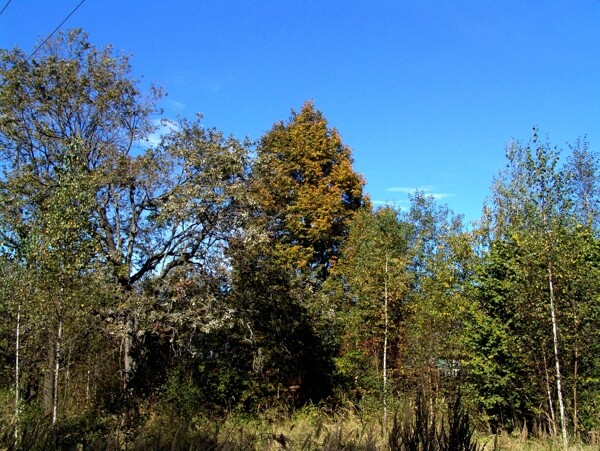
[402,192,476,396]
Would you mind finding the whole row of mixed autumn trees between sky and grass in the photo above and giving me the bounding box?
[0,30,600,443]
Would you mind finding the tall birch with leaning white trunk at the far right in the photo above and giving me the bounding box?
[481,131,597,446]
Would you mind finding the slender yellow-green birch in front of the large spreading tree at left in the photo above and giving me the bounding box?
[0,135,105,423]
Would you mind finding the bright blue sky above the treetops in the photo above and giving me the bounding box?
[0,0,600,224]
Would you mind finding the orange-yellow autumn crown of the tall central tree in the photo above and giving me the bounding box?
[252,102,364,274]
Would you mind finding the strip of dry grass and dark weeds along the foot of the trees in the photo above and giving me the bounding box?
[0,395,600,451]
